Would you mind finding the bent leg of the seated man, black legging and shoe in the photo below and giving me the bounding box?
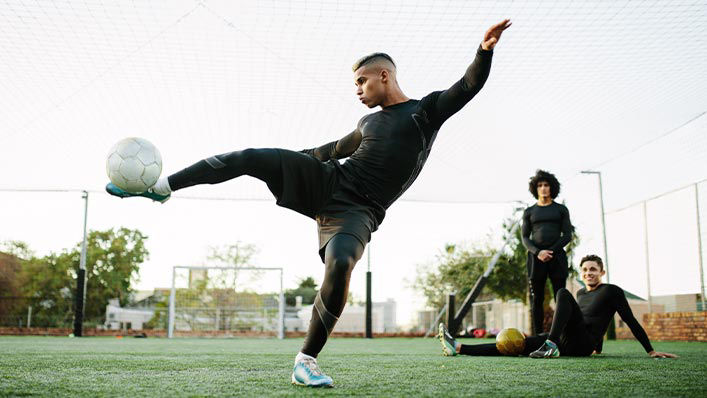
[530,288,586,358]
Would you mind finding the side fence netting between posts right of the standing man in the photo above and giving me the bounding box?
[607,182,707,304]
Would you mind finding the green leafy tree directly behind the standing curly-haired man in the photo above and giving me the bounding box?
[412,219,579,308]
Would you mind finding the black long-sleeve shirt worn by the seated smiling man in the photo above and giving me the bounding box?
[577,283,653,352]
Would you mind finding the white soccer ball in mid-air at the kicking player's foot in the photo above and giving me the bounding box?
[106,137,162,193]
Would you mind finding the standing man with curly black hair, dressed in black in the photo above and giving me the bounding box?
[522,170,572,334]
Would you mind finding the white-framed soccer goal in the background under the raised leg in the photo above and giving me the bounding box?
[167,266,285,339]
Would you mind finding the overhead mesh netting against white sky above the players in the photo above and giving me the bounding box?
[0,0,707,201]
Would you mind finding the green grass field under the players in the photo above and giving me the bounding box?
[0,337,707,397]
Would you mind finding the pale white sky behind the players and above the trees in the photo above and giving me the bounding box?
[0,0,707,324]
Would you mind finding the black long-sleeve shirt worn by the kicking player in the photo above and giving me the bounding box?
[303,47,493,213]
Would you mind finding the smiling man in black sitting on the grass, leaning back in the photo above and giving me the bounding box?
[439,255,677,358]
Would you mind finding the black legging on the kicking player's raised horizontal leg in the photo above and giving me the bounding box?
[168,148,282,197]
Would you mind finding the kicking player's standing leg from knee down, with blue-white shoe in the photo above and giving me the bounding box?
[292,234,364,386]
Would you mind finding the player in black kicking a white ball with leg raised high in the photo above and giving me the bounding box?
[106,19,511,386]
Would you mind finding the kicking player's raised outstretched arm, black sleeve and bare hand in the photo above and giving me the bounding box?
[432,19,511,125]
